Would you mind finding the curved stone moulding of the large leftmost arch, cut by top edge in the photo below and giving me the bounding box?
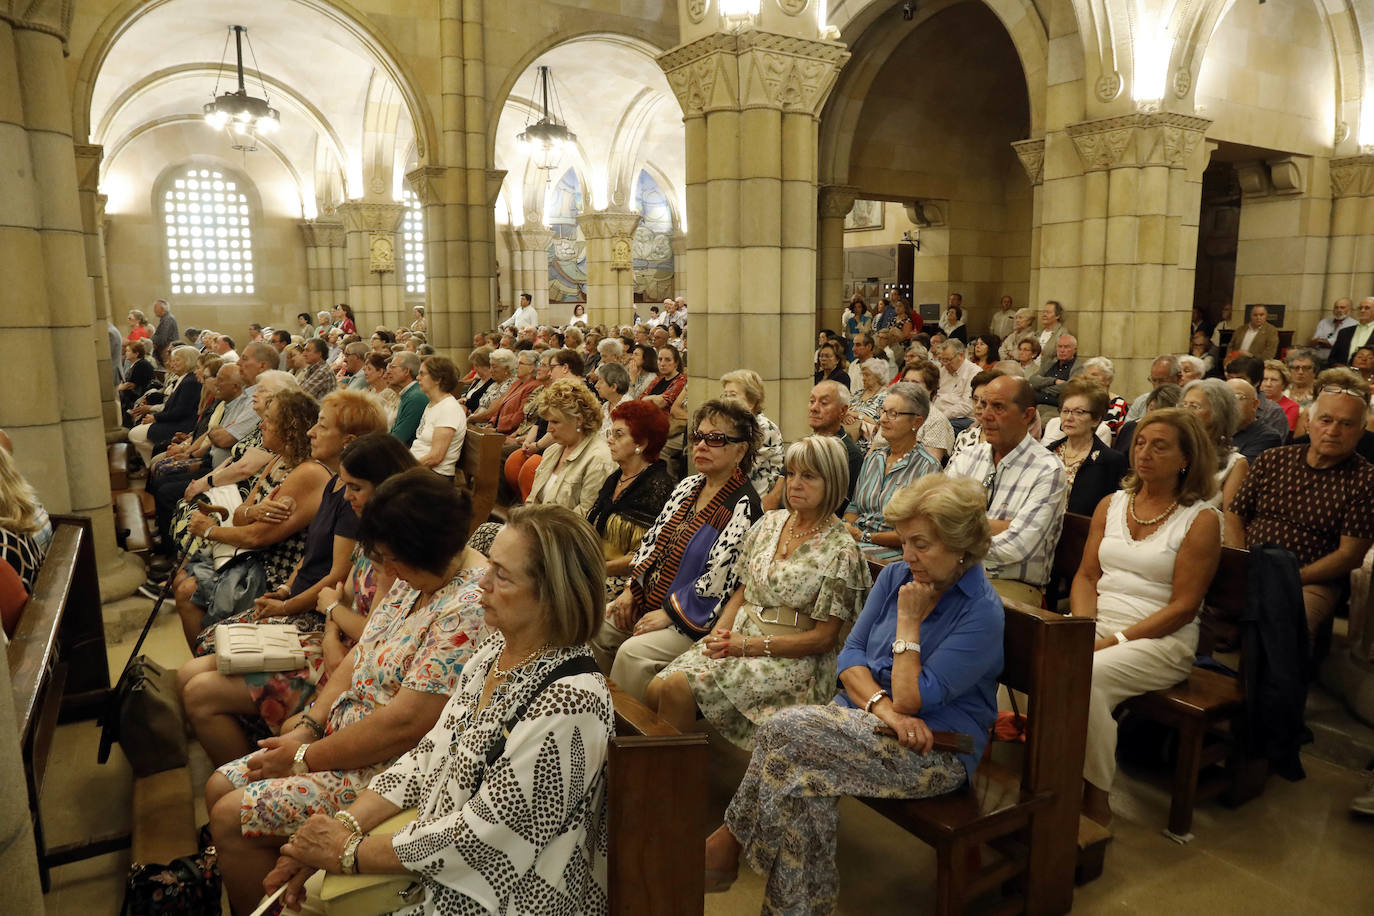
[71,0,438,163]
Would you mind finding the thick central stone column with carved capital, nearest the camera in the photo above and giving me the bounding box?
[658,24,849,439]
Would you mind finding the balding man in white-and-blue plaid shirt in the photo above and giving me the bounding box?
[945,375,1069,607]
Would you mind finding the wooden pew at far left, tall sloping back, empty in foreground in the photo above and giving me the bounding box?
[8,515,115,893]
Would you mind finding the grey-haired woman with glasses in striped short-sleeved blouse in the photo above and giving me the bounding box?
[845,382,940,551]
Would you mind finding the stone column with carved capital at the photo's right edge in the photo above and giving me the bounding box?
[1322,155,1374,306]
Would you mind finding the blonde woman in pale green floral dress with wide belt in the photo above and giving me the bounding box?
[646,435,872,750]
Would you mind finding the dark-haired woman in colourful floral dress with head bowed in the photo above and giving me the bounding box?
[205,468,486,912]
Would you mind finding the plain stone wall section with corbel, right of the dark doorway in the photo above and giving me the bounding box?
[1234,157,1324,345]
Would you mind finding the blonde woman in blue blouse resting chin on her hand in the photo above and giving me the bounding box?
[706,474,1003,915]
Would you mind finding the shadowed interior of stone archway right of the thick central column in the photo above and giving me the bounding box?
[818,0,1036,332]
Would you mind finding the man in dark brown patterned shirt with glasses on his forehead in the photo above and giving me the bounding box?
[1226,369,1374,634]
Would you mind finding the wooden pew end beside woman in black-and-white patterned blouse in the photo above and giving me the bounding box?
[606,678,709,916]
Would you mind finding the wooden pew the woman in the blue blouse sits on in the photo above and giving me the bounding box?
[860,600,1094,915]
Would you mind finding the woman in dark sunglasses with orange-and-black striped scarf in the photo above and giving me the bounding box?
[592,400,763,698]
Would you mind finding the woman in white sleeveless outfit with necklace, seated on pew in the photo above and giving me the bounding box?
[1069,408,1221,825]
